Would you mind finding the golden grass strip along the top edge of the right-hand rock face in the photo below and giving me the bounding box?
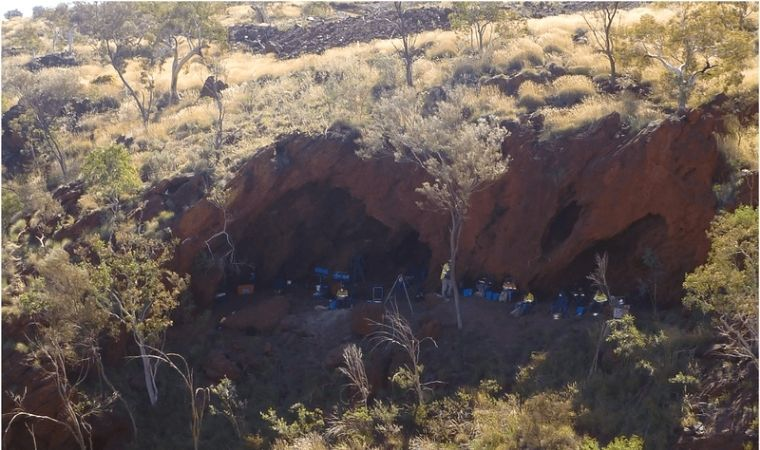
[541,95,663,140]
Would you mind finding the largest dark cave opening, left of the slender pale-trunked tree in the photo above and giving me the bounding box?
[235,183,431,292]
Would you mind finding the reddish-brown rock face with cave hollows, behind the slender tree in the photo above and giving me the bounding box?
[175,100,732,308]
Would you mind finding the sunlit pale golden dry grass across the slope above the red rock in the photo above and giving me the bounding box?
[3,2,696,194]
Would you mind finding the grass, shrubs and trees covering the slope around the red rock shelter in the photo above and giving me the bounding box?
[2,2,758,450]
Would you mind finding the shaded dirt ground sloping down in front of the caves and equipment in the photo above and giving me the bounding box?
[186,286,601,410]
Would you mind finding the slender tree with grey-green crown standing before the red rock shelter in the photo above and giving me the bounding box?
[360,89,509,329]
